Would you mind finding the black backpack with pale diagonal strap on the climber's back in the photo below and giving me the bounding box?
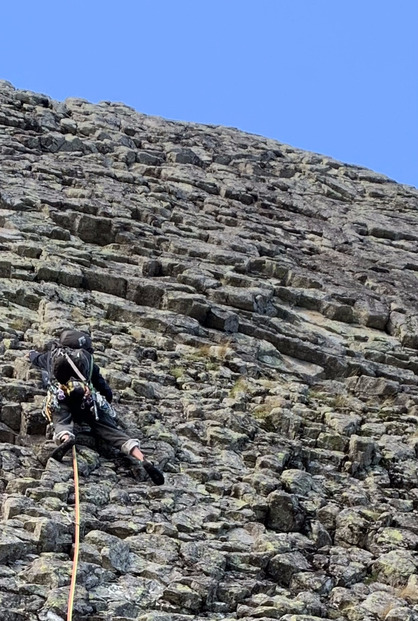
[48,343,93,384]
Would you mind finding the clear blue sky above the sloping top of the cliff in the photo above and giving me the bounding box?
[0,0,418,187]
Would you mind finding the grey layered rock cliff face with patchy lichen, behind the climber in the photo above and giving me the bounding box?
[0,82,418,621]
